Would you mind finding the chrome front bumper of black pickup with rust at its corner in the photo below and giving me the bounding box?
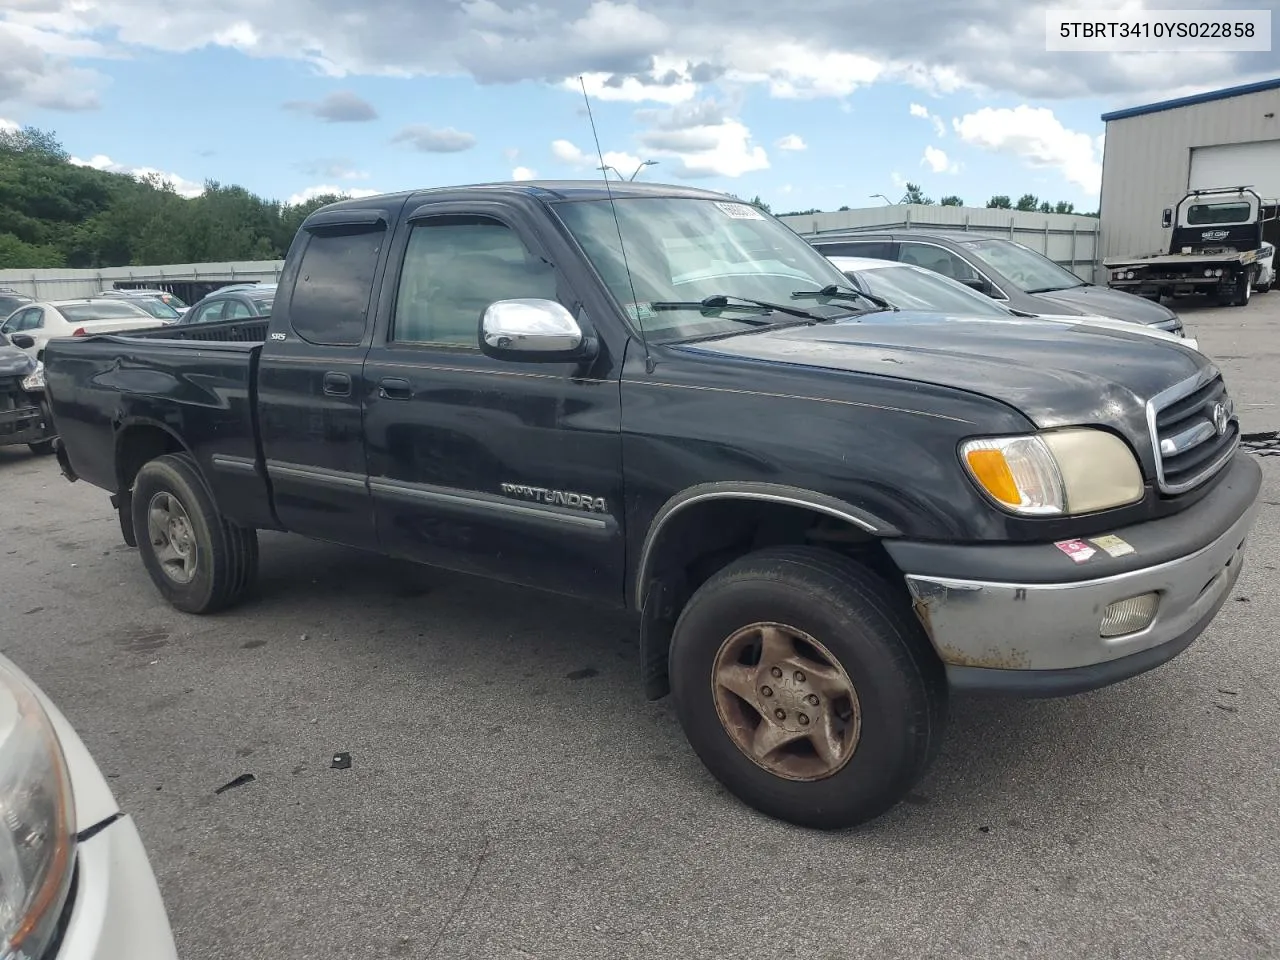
[906,491,1260,696]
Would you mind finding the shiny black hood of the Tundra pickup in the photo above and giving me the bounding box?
[681,311,1210,451]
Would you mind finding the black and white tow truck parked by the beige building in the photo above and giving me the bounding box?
[1102,187,1280,307]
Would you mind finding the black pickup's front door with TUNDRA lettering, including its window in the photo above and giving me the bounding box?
[364,202,625,600]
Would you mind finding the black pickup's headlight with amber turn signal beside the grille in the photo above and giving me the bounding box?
[960,428,1143,517]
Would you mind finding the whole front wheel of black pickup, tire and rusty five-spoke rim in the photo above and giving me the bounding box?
[669,547,947,829]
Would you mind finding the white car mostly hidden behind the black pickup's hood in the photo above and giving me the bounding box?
[827,256,1199,349]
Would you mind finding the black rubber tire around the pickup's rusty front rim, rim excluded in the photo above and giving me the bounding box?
[669,547,948,829]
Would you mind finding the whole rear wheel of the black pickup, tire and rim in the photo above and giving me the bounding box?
[132,453,257,613]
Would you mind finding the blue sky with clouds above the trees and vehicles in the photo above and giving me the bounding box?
[0,0,1280,211]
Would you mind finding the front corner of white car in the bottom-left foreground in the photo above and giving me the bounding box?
[0,655,178,960]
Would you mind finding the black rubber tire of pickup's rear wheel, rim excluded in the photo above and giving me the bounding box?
[132,453,257,613]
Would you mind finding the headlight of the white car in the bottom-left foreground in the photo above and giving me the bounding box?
[0,668,76,957]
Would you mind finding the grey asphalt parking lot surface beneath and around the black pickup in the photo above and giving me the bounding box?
[0,292,1280,960]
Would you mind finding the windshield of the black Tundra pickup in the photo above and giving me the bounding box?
[554,197,864,340]
